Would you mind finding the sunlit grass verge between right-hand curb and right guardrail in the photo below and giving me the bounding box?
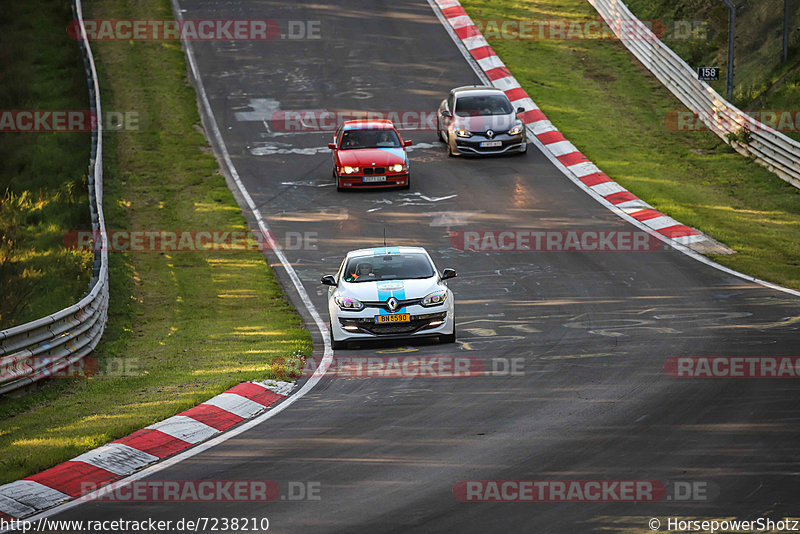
[462,0,800,288]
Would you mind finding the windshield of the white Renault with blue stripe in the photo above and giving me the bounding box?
[344,253,436,283]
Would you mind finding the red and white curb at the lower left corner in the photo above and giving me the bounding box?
[0,380,294,519]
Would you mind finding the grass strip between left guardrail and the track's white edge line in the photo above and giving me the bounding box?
[0,0,311,483]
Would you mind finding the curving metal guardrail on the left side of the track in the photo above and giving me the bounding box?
[0,0,108,394]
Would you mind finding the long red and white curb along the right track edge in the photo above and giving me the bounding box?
[429,0,709,249]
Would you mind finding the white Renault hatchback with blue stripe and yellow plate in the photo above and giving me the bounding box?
[321,247,456,349]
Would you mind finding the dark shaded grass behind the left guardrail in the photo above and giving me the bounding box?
[0,0,92,330]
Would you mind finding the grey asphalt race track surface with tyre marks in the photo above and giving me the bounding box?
[56,0,800,533]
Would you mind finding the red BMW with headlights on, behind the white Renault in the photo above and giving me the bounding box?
[328,120,411,191]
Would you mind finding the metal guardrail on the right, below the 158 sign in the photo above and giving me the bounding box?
[589,0,800,188]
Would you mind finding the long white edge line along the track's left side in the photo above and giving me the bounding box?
[19,0,333,521]
